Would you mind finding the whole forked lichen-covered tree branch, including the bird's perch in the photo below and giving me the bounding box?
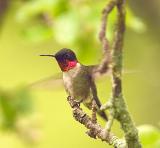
[68,0,141,148]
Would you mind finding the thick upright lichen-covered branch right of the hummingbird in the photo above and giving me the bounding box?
[111,0,141,148]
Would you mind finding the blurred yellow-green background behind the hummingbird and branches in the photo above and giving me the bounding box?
[0,0,160,148]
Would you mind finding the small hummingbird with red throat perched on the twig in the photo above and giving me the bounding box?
[40,48,108,121]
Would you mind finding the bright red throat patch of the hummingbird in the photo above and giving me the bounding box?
[59,60,77,71]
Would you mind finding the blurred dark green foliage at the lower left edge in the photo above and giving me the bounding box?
[0,87,32,129]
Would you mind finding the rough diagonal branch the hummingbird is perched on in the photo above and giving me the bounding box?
[67,96,126,148]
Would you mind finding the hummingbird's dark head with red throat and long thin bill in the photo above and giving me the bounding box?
[40,48,78,72]
